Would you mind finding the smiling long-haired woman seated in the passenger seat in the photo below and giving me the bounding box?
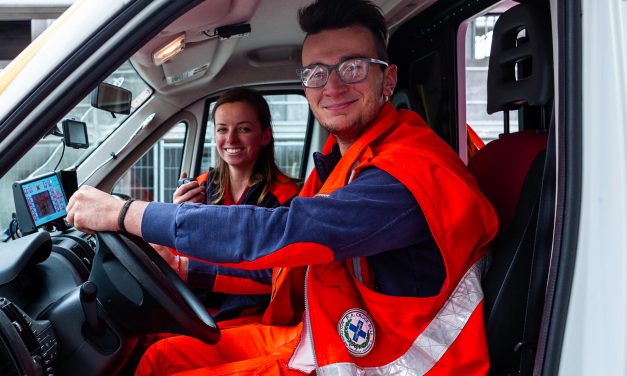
[159,88,299,320]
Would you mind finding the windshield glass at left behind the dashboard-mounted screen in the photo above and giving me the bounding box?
[0,61,152,239]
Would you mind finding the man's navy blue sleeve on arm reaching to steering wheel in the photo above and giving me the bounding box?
[142,168,430,266]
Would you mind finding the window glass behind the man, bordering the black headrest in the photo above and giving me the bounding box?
[465,14,518,143]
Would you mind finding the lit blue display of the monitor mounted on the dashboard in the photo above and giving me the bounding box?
[22,175,67,227]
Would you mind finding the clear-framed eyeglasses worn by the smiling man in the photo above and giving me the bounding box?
[296,57,389,88]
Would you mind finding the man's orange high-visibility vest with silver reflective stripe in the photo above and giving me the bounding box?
[264,104,498,375]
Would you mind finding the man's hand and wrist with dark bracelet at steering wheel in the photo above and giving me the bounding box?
[67,186,148,236]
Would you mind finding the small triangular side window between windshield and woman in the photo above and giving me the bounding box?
[113,123,187,202]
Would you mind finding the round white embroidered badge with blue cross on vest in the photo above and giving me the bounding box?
[337,308,375,357]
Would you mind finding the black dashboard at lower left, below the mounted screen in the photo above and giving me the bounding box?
[0,230,96,376]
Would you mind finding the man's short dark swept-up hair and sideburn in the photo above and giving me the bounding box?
[298,0,389,61]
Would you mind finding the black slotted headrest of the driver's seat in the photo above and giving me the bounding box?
[487,3,553,114]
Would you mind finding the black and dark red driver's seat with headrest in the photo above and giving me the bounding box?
[468,2,555,375]
